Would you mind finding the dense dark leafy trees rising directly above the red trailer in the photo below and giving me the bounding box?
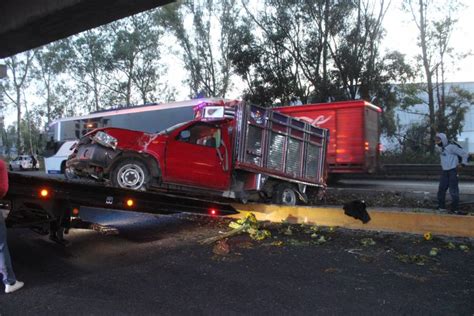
[230,0,413,136]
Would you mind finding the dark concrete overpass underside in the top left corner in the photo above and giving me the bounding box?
[0,0,173,58]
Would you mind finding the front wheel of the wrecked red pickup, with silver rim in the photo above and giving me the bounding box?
[110,158,150,191]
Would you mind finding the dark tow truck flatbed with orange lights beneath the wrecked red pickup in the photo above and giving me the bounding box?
[0,172,237,244]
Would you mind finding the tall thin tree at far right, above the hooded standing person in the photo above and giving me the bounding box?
[404,0,473,152]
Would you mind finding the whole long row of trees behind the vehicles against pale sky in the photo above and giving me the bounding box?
[0,0,474,158]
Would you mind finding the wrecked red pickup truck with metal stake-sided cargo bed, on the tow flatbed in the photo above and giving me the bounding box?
[67,101,329,205]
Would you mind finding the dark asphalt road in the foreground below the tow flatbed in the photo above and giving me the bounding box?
[0,210,474,315]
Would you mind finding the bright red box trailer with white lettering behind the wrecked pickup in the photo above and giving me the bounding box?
[274,100,382,174]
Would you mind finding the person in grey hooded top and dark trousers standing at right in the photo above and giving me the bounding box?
[435,133,469,215]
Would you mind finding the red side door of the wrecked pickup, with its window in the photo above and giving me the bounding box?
[163,122,231,190]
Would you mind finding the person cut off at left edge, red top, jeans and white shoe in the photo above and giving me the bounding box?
[0,160,24,293]
